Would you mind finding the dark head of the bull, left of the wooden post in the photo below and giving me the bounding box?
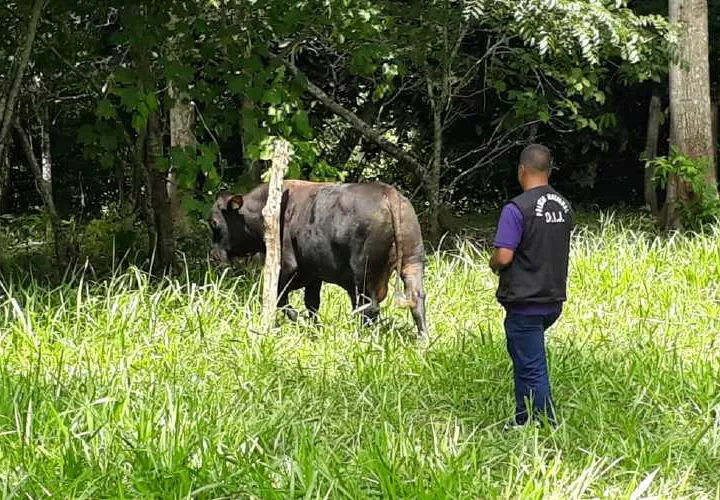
[208,193,262,264]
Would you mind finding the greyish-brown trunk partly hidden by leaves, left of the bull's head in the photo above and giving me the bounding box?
[167,82,195,235]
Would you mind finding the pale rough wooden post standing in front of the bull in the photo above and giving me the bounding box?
[262,139,290,333]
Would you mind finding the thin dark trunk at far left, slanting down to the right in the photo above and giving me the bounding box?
[13,120,76,269]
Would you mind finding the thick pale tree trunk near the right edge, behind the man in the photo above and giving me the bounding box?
[665,0,716,228]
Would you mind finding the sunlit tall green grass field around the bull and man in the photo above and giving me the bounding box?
[0,213,720,498]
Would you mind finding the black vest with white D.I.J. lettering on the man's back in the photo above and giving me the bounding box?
[496,186,575,304]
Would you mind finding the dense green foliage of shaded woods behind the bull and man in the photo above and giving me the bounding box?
[0,0,708,270]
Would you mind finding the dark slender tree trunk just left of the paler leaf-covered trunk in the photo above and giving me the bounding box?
[145,112,175,272]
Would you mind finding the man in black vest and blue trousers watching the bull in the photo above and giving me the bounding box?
[490,144,575,428]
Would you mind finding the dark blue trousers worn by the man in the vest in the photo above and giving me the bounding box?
[505,311,560,425]
